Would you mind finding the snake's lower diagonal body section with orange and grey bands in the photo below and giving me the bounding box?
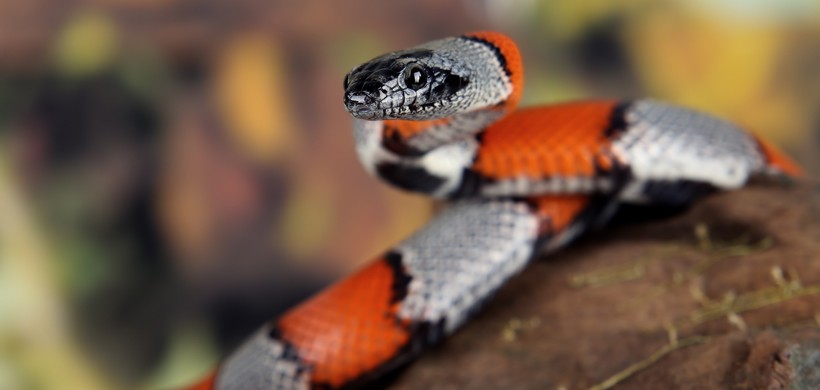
[209,197,590,389]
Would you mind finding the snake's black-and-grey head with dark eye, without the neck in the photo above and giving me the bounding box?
[344,45,471,120]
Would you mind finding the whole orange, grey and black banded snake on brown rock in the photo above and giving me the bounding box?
[193,31,801,390]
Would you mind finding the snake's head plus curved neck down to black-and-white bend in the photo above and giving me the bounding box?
[345,32,523,197]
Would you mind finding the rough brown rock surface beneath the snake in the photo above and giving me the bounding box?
[392,183,820,389]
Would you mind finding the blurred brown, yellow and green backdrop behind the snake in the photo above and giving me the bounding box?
[0,0,820,390]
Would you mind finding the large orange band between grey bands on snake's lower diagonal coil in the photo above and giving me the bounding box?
[277,260,409,386]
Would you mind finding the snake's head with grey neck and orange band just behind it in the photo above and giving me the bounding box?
[344,32,523,120]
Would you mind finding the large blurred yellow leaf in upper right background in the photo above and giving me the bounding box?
[626,9,783,112]
